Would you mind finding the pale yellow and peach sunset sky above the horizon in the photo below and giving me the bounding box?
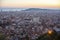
[0,0,60,8]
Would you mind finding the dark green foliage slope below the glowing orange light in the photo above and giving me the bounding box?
[36,31,60,40]
